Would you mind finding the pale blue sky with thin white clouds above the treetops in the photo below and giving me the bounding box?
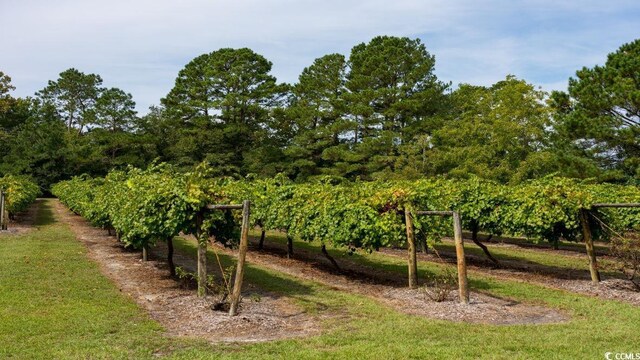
[0,0,640,113]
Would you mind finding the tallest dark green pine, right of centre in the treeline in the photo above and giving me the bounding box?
[346,36,447,177]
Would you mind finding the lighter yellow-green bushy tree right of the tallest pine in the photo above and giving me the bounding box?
[427,76,552,183]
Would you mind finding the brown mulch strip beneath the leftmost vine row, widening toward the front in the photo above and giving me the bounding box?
[52,200,320,342]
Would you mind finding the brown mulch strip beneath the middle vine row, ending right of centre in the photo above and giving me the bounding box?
[202,239,569,325]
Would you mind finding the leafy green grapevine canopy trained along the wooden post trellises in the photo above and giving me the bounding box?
[53,164,640,250]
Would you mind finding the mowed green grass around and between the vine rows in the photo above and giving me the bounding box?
[0,201,640,359]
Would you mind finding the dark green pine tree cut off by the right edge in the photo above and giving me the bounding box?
[561,39,640,178]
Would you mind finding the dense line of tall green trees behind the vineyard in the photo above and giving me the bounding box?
[0,36,640,189]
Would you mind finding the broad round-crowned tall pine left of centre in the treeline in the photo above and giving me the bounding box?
[162,48,286,174]
